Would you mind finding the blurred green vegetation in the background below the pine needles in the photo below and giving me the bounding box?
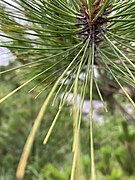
[0,61,135,180]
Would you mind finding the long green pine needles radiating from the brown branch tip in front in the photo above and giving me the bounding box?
[0,0,135,179]
